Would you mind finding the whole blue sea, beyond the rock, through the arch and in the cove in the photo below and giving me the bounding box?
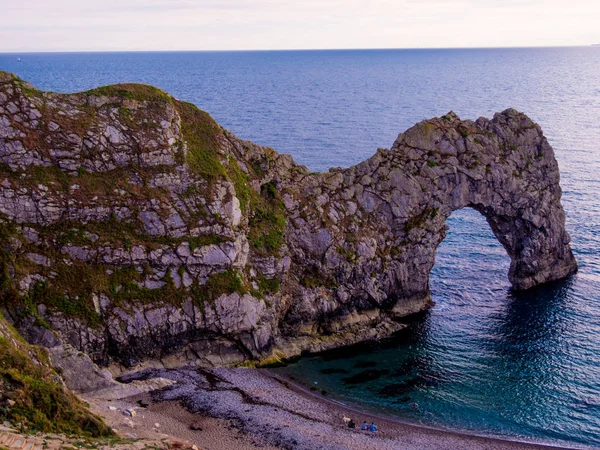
[0,47,600,446]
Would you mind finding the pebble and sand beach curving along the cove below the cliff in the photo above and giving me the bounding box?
[88,368,584,450]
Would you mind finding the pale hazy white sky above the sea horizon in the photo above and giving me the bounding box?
[0,0,600,52]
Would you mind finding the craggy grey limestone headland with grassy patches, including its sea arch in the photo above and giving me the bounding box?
[0,73,577,366]
